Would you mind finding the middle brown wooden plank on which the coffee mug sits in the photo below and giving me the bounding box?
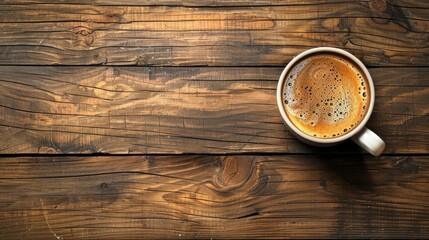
[0,66,429,154]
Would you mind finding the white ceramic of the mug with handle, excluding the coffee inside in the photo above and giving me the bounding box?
[277,47,386,156]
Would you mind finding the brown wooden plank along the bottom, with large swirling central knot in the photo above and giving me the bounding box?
[0,155,429,239]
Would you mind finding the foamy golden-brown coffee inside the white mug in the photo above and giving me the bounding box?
[282,53,372,138]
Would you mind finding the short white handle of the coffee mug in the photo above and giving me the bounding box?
[352,127,386,156]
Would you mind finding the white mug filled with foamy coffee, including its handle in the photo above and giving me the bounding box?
[277,47,386,156]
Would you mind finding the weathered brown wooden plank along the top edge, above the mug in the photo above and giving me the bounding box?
[0,1,429,66]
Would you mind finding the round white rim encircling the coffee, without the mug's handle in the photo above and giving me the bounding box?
[277,47,375,144]
